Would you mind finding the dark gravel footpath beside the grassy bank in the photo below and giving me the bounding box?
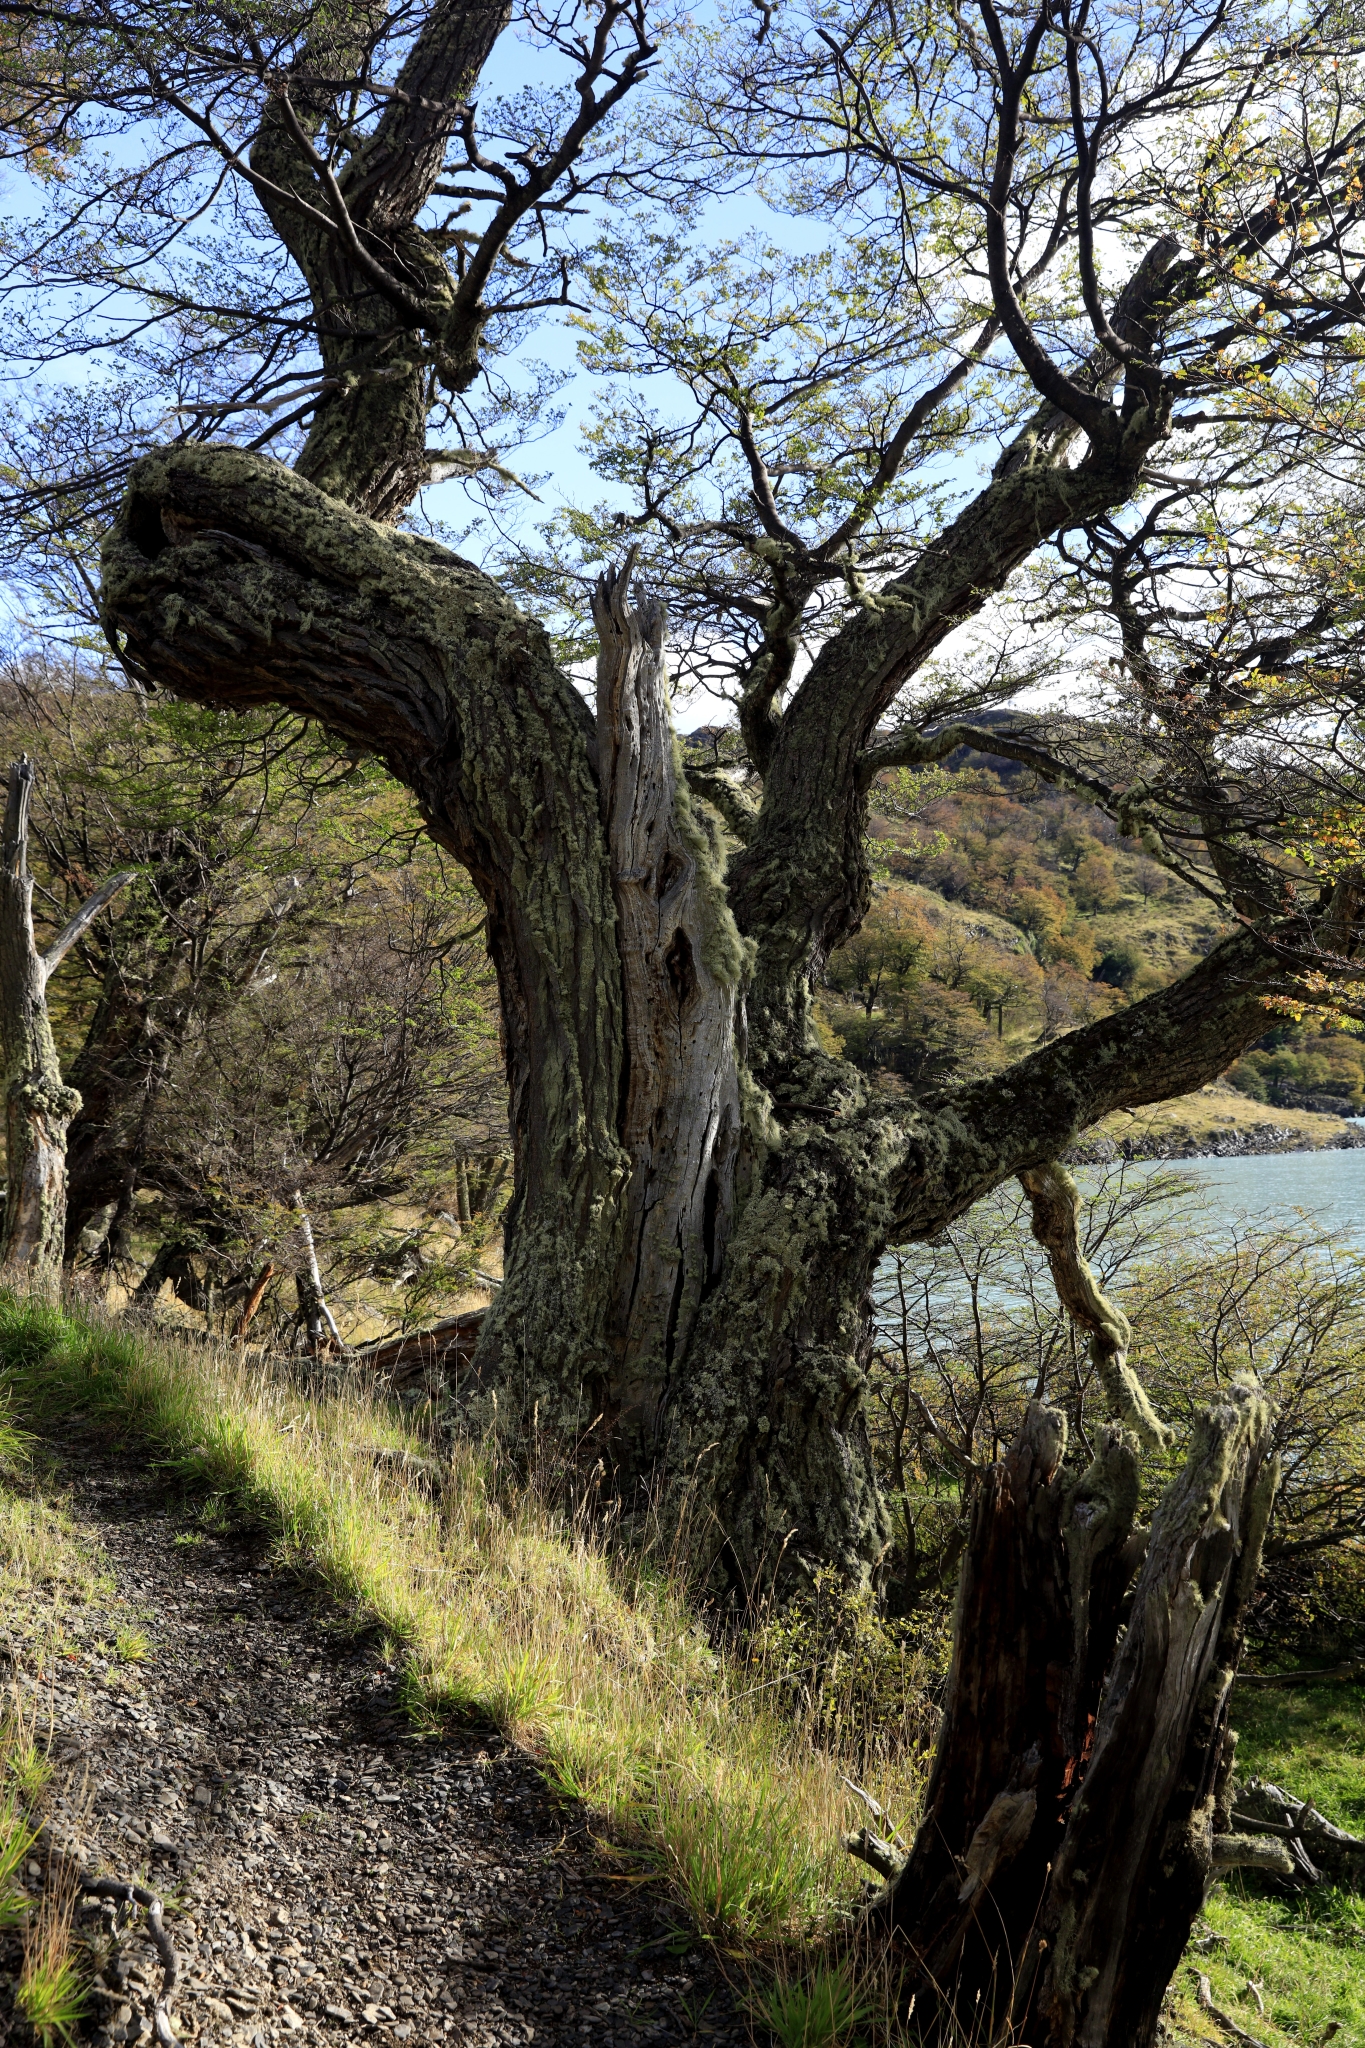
[10,1432,751,2048]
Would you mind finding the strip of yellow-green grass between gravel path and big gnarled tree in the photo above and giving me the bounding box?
[0,1300,925,1982]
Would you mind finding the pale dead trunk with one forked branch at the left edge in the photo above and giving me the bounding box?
[0,756,131,1296]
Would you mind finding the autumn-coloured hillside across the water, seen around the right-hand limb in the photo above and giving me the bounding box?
[819,752,1365,1155]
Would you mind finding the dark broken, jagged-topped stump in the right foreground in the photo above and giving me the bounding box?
[888,1382,1277,2048]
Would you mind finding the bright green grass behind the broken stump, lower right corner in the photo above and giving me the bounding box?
[1175,1686,1365,2048]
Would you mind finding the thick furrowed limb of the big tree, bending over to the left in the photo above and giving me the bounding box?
[104,449,628,1432]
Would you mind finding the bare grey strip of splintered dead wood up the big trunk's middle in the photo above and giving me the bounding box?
[593,557,743,1442]
